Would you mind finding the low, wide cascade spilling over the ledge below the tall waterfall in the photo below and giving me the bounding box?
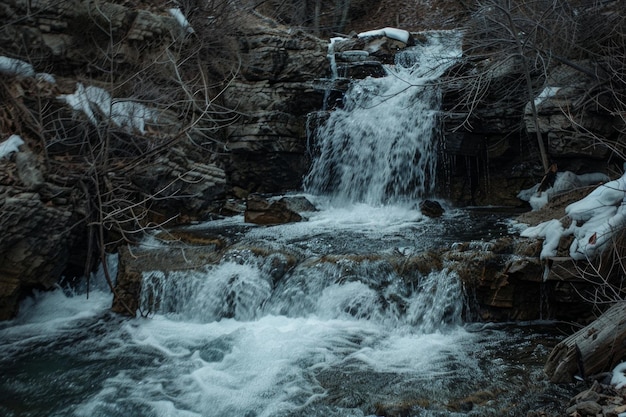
[141,249,464,333]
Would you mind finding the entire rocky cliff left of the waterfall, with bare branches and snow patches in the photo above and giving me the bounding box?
[0,0,327,319]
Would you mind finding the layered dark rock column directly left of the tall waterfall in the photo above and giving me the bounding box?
[224,20,328,193]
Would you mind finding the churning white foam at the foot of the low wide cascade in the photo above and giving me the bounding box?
[66,316,480,417]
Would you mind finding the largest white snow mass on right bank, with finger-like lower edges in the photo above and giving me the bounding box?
[521,174,626,260]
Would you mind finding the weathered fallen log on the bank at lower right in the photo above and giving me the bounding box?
[544,302,626,383]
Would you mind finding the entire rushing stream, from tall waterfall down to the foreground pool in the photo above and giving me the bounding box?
[0,30,569,417]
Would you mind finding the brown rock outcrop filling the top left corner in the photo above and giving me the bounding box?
[0,0,184,74]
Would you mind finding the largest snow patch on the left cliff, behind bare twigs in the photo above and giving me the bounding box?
[57,83,157,133]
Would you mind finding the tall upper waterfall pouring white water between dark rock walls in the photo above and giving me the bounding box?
[304,31,461,205]
